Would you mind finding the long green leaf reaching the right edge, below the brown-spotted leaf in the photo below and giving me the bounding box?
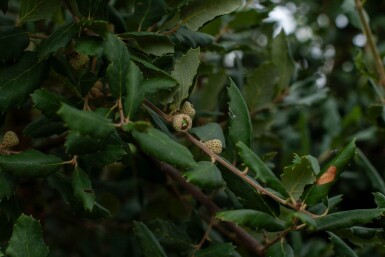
[316,208,385,231]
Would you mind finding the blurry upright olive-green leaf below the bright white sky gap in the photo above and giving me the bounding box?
[271,30,295,90]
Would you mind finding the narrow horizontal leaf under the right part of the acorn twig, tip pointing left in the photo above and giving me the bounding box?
[216,209,286,232]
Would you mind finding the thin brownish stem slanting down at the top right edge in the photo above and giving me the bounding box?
[355,0,385,88]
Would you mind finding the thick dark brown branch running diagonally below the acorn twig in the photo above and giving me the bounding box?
[154,159,263,256]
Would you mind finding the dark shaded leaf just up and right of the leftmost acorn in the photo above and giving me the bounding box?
[23,117,67,138]
